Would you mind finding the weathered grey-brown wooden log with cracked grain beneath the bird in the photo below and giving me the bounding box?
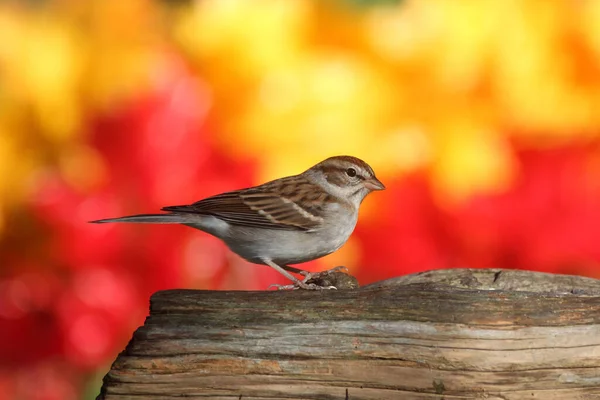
[98,269,600,400]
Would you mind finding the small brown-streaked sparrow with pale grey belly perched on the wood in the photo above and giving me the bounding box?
[91,156,385,289]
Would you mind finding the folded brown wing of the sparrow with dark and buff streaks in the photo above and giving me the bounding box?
[163,182,328,231]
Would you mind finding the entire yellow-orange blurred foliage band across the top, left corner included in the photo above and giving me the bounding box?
[0,0,600,228]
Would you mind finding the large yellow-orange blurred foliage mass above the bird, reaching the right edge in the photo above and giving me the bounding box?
[170,0,600,203]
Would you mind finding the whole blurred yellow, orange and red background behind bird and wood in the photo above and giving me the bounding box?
[0,0,600,400]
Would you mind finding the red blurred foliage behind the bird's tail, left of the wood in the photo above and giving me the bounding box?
[0,54,254,399]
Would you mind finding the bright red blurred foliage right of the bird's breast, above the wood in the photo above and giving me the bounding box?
[355,141,600,284]
